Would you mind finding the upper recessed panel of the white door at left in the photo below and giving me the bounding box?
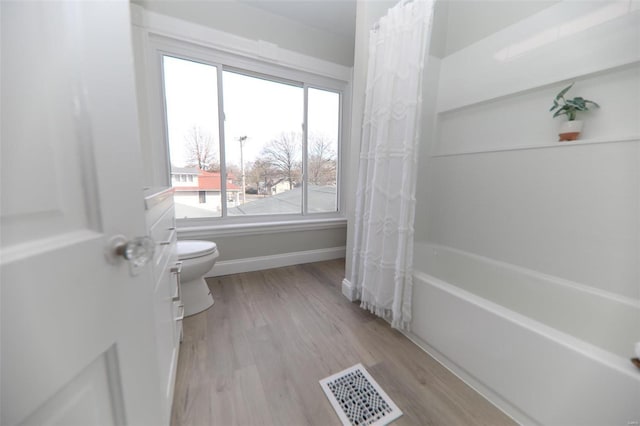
[2,2,97,244]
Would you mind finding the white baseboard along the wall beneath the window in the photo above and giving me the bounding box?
[205,247,346,278]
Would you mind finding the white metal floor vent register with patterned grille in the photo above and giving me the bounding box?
[320,364,402,426]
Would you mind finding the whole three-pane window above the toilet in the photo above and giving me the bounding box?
[162,54,341,219]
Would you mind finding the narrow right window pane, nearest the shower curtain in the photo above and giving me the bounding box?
[307,89,340,213]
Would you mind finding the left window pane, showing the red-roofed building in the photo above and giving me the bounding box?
[163,56,222,218]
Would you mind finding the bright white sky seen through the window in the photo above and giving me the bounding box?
[164,56,339,167]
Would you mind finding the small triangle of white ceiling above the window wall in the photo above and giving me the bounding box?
[237,0,356,40]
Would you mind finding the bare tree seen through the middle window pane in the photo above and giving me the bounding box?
[262,132,302,189]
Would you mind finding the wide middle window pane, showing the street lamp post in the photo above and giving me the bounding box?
[222,71,304,216]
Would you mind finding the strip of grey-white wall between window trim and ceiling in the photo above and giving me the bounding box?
[127,0,353,67]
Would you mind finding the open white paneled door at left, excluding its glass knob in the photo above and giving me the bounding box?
[0,1,162,426]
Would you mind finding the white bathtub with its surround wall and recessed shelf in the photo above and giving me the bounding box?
[404,1,640,425]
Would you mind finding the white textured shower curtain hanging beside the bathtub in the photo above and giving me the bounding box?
[351,0,433,329]
